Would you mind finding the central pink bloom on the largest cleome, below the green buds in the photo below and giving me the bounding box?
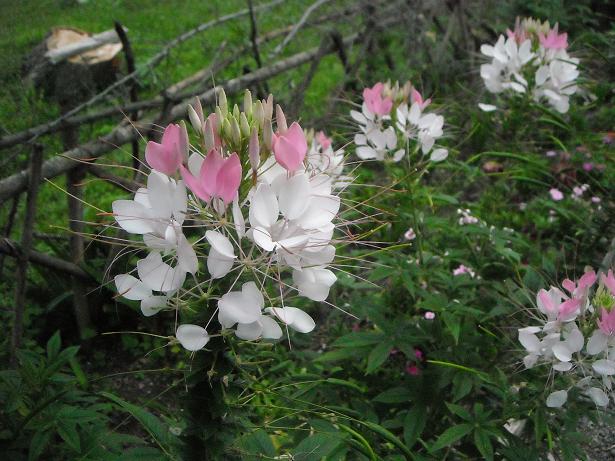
[180,149,241,205]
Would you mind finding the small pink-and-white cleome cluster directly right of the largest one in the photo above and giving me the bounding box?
[350,82,448,162]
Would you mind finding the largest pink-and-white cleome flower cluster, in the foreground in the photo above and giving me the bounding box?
[113,91,350,351]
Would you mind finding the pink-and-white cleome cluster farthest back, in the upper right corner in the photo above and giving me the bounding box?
[479,18,579,113]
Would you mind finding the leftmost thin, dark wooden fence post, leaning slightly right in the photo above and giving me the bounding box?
[11,144,43,365]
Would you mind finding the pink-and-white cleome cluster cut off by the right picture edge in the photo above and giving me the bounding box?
[519,270,615,407]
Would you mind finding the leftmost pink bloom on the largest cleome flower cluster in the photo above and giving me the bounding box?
[145,123,189,175]
